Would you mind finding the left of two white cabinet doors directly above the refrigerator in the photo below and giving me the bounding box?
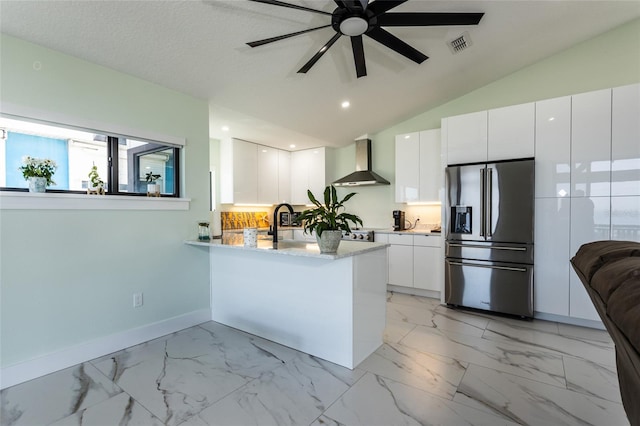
[447,111,487,164]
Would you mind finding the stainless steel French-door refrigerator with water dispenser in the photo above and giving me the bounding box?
[445,159,534,317]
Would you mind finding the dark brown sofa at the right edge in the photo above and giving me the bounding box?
[571,241,640,426]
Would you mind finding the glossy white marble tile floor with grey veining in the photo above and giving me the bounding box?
[0,293,629,426]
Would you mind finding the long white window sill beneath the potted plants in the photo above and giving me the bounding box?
[0,191,191,210]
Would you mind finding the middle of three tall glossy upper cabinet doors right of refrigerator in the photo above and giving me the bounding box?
[571,89,611,197]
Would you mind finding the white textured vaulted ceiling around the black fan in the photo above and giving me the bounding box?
[0,0,640,149]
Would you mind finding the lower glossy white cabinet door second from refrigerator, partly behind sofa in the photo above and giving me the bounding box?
[566,197,611,321]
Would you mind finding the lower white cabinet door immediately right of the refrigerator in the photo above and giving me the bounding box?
[533,197,571,316]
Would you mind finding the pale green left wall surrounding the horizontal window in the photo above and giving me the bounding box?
[0,35,209,367]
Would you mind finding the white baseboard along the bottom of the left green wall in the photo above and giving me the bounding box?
[0,309,211,389]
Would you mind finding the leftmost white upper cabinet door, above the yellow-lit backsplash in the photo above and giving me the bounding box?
[233,139,258,204]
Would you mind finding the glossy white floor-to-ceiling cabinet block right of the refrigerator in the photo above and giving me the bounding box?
[535,84,640,320]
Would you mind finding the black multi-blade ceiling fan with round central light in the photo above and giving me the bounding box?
[247,0,484,78]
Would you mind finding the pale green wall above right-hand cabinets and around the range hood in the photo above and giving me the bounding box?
[333,19,640,227]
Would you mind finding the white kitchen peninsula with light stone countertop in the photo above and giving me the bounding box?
[187,235,387,368]
